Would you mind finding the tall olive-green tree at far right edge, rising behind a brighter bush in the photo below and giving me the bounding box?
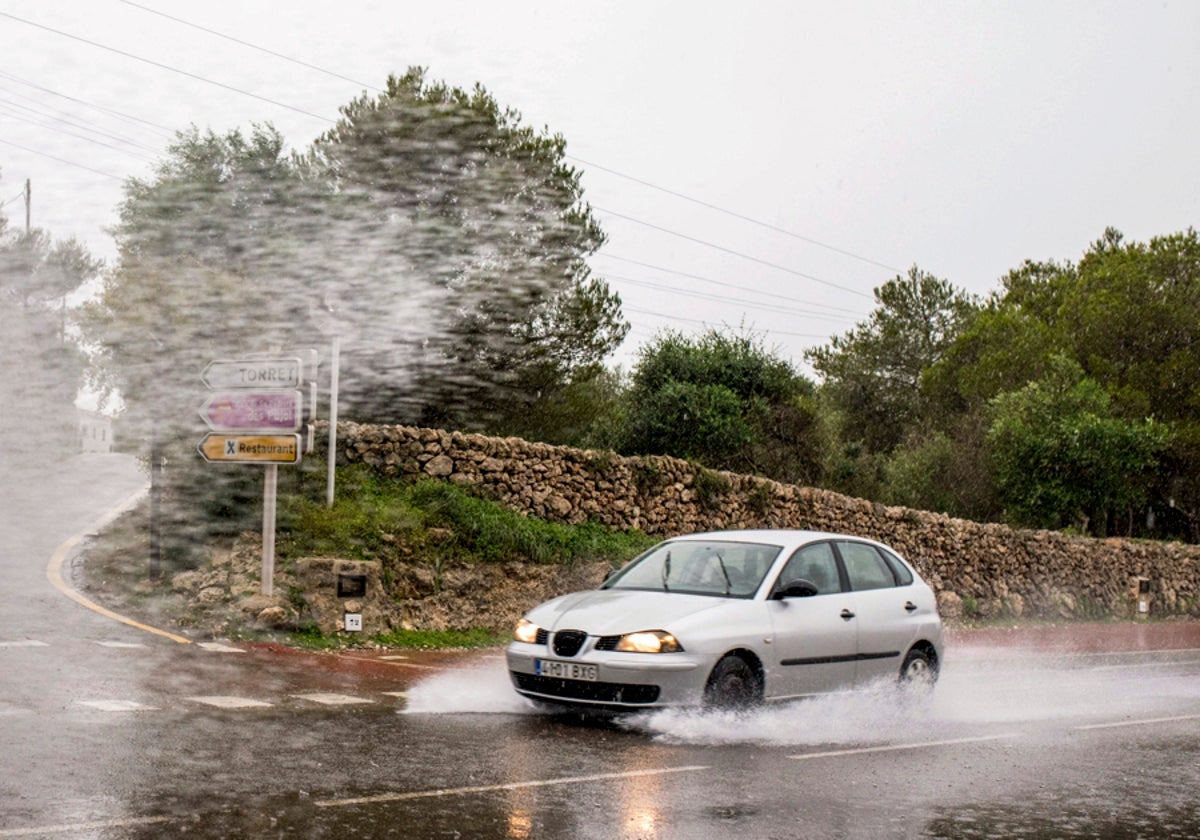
[924,228,1200,541]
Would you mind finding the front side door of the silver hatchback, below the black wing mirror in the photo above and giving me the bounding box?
[766,541,858,697]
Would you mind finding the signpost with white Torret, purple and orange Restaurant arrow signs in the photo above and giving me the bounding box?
[197,350,317,595]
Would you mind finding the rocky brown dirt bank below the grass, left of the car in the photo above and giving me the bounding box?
[71,533,610,641]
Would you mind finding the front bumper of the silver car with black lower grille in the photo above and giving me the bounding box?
[505,642,713,710]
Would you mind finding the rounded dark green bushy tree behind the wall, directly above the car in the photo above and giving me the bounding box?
[622,330,820,482]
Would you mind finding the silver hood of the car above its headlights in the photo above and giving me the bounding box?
[528,589,730,636]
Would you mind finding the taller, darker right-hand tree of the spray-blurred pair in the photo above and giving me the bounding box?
[305,68,629,428]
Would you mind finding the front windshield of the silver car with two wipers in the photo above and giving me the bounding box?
[604,540,781,598]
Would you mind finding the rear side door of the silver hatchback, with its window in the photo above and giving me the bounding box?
[836,540,919,685]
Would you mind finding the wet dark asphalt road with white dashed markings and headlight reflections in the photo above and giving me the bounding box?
[0,456,1200,840]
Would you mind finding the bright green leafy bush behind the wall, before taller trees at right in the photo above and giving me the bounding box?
[988,355,1170,535]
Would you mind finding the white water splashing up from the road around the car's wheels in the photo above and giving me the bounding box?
[404,656,1200,746]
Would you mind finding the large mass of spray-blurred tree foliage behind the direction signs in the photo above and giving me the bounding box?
[82,70,628,556]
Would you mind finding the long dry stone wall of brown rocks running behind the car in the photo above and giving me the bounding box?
[318,422,1200,618]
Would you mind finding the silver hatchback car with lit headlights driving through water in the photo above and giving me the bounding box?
[506,530,942,712]
